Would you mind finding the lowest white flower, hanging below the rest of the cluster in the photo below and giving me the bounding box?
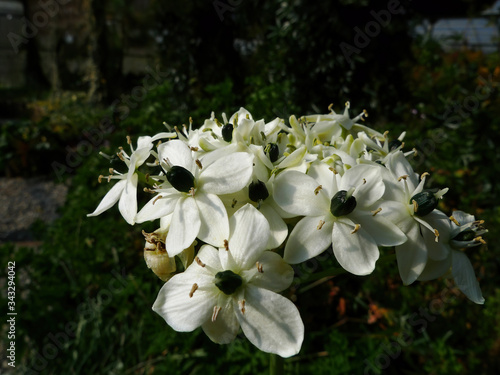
[153,205,304,357]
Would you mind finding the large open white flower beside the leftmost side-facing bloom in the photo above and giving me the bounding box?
[136,140,253,257]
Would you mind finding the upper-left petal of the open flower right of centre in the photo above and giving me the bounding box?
[274,171,330,216]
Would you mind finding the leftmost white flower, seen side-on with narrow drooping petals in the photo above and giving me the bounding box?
[87,134,153,225]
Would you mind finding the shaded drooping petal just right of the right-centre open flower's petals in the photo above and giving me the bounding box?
[396,221,427,285]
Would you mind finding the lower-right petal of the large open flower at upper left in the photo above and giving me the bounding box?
[195,191,229,247]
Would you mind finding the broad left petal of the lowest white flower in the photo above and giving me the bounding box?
[153,270,217,332]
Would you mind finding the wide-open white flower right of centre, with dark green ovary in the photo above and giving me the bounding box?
[274,163,406,275]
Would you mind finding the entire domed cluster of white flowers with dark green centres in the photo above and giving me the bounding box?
[89,103,486,357]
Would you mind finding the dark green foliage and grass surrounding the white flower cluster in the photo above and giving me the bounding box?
[0,0,500,374]
